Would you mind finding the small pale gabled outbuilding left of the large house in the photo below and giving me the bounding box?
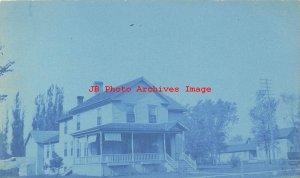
[25,131,59,175]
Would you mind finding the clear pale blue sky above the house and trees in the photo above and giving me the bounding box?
[0,0,300,140]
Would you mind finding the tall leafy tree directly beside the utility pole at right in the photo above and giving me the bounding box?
[250,90,278,163]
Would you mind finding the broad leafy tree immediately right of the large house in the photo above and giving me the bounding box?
[186,99,238,164]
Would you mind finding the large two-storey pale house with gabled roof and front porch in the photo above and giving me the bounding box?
[25,77,196,176]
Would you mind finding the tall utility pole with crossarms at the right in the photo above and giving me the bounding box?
[260,79,275,161]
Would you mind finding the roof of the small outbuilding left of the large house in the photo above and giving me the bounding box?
[25,130,59,144]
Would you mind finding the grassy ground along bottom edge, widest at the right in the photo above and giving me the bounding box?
[0,164,300,178]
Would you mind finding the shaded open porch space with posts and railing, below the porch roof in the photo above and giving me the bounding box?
[74,132,183,165]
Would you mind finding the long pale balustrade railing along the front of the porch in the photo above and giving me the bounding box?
[74,153,164,164]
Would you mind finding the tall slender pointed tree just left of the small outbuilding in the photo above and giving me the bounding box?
[11,92,25,157]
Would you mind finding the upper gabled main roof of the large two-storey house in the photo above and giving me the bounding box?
[59,77,185,121]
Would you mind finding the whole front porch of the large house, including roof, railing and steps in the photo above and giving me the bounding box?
[72,123,196,175]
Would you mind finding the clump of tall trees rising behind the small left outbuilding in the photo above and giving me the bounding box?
[32,85,64,130]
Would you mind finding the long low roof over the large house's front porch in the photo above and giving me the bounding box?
[71,122,188,136]
